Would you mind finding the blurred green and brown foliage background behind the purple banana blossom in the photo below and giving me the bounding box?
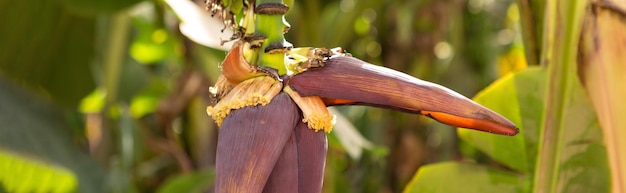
[0,0,526,192]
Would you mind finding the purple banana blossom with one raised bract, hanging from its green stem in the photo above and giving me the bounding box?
[199,0,519,192]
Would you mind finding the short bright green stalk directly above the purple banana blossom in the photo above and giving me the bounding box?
[254,0,289,74]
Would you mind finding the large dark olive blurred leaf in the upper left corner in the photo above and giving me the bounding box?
[0,0,96,107]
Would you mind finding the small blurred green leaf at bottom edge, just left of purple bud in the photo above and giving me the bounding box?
[157,170,215,193]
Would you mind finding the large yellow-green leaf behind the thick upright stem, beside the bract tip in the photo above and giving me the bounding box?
[459,65,610,192]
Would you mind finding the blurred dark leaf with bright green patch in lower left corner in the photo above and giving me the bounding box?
[0,78,106,192]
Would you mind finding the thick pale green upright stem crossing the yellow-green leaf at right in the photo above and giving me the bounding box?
[533,0,587,193]
